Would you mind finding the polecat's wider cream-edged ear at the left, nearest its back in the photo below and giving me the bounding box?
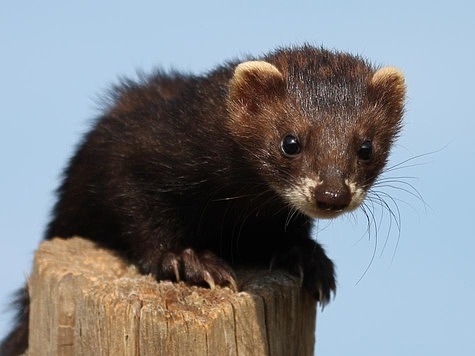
[228,61,285,113]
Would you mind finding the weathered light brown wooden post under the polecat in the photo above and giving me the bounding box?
[27,238,316,356]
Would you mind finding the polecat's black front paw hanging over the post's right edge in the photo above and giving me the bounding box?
[272,239,336,306]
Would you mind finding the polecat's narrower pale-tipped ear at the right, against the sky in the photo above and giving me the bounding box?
[371,67,406,118]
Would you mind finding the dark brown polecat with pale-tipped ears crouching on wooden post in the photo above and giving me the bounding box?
[1,46,405,354]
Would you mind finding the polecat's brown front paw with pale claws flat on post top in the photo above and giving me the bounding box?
[144,248,238,291]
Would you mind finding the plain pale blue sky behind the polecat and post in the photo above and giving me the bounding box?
[0,0,475,356]
